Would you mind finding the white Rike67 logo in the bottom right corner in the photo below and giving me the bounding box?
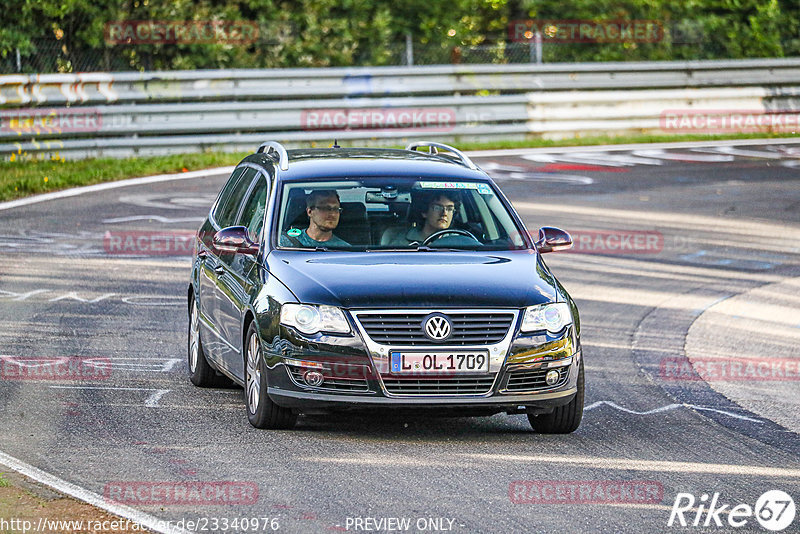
[667,490,795,532]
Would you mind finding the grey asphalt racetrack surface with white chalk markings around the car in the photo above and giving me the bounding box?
[0,142,800,533]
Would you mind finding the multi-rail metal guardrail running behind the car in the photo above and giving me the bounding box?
[0,59,800,160]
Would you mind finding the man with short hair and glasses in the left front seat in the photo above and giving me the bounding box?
[280,190,350,248]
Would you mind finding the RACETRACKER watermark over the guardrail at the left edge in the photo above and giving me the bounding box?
[0,107,103,134]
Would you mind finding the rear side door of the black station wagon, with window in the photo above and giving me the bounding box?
[198,167,253,364]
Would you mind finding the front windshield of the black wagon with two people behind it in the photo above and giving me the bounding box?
[274,178,527,251]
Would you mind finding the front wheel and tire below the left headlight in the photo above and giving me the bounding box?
[244,322,297,430]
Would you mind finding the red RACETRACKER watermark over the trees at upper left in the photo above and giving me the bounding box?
[104,20,259,45]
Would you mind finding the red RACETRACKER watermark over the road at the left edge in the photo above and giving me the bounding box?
[0,356,111,381]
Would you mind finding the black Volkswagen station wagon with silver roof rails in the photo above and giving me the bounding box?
[188,142,584,433]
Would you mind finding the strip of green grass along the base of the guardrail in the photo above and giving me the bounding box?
[0,134,797,201]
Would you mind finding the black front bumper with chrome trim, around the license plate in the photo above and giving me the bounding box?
[264,310,582,413]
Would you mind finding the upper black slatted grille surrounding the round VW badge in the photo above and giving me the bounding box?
[356,311,515,346]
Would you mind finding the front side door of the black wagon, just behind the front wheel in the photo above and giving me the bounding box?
[217,168,268,378]
